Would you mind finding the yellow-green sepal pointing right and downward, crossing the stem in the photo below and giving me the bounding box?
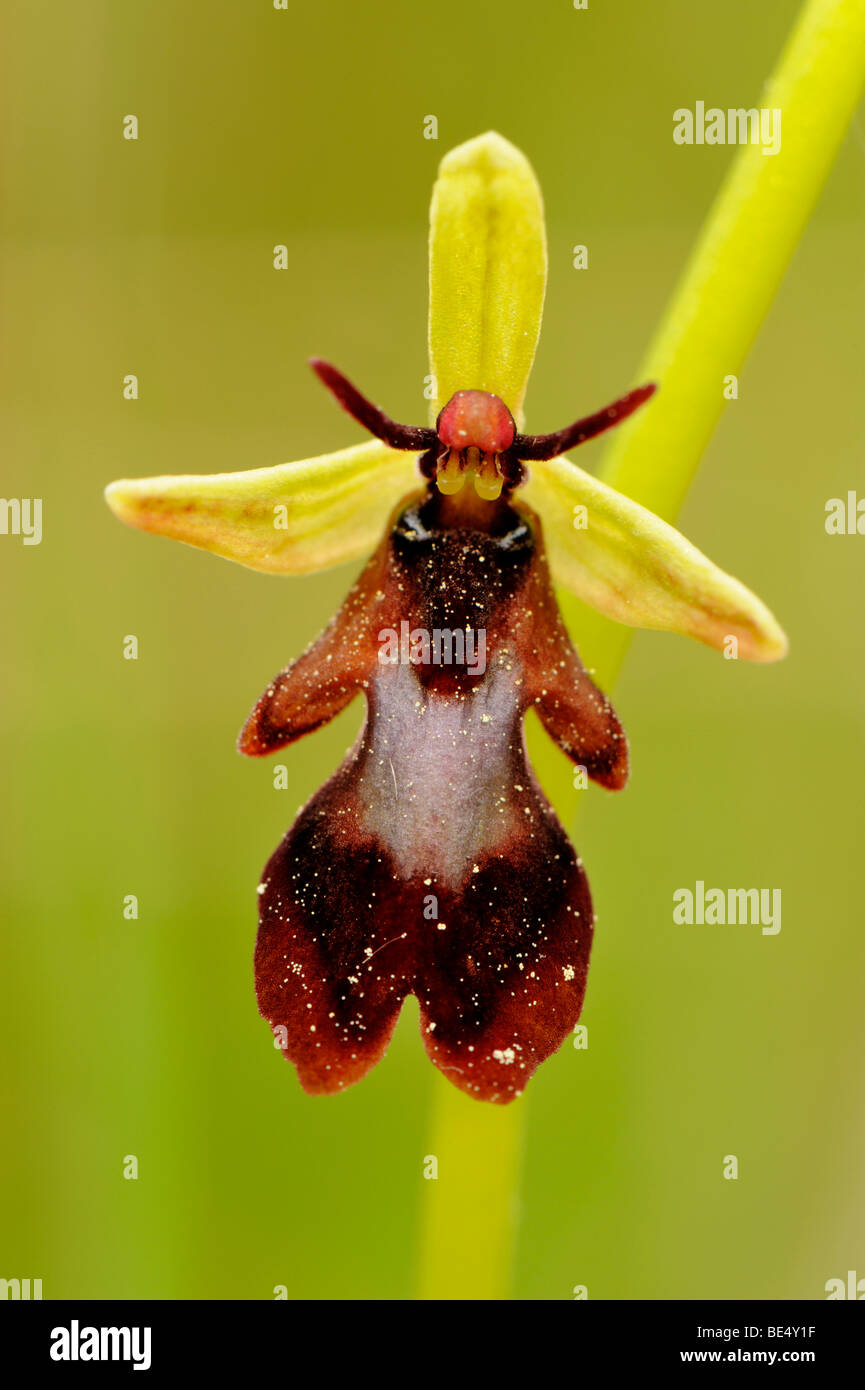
[520,459,787,662]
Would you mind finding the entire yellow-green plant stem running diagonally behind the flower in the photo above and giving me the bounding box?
[419,0,865,1300]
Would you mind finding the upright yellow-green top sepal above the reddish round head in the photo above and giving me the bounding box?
[430,131,547,424]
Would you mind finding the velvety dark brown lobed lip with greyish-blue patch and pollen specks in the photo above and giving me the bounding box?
[241,493,627,1101]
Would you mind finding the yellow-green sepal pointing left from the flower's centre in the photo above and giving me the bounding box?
[106,441,420,574]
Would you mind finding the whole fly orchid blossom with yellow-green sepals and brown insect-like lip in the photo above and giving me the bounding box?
[107,133,786,1102]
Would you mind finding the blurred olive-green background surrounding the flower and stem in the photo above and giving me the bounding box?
[0,0,865,1300]
